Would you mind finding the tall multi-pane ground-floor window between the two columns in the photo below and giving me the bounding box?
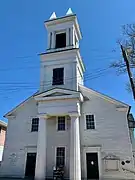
[56,147,65,167]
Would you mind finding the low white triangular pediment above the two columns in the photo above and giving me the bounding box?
[35,88,81,100]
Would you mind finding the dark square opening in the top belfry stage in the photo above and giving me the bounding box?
[55,33,66,48]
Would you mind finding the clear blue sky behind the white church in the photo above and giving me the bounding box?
[0,0,135,119]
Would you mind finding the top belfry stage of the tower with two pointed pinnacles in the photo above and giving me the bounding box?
[45,8,82,52]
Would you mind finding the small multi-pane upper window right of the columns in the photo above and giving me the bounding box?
[86,114,95,129]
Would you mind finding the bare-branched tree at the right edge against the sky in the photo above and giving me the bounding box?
[111,24,135,99]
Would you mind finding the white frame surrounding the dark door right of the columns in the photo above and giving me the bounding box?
[83,146,102,179]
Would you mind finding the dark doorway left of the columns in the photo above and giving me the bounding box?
[25,153,36,177]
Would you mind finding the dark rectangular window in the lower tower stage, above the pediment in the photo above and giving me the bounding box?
[52,68,64,85]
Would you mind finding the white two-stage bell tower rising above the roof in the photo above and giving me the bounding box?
[40,8,84,92]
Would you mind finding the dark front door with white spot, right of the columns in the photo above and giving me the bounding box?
[86,153,99,180]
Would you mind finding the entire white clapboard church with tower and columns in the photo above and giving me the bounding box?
[0,10,135,180]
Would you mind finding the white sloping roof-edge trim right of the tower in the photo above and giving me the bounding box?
[79,85,130,109]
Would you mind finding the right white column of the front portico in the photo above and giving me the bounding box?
[70,116,81,180]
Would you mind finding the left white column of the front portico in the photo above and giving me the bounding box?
[35,117,46,180]
